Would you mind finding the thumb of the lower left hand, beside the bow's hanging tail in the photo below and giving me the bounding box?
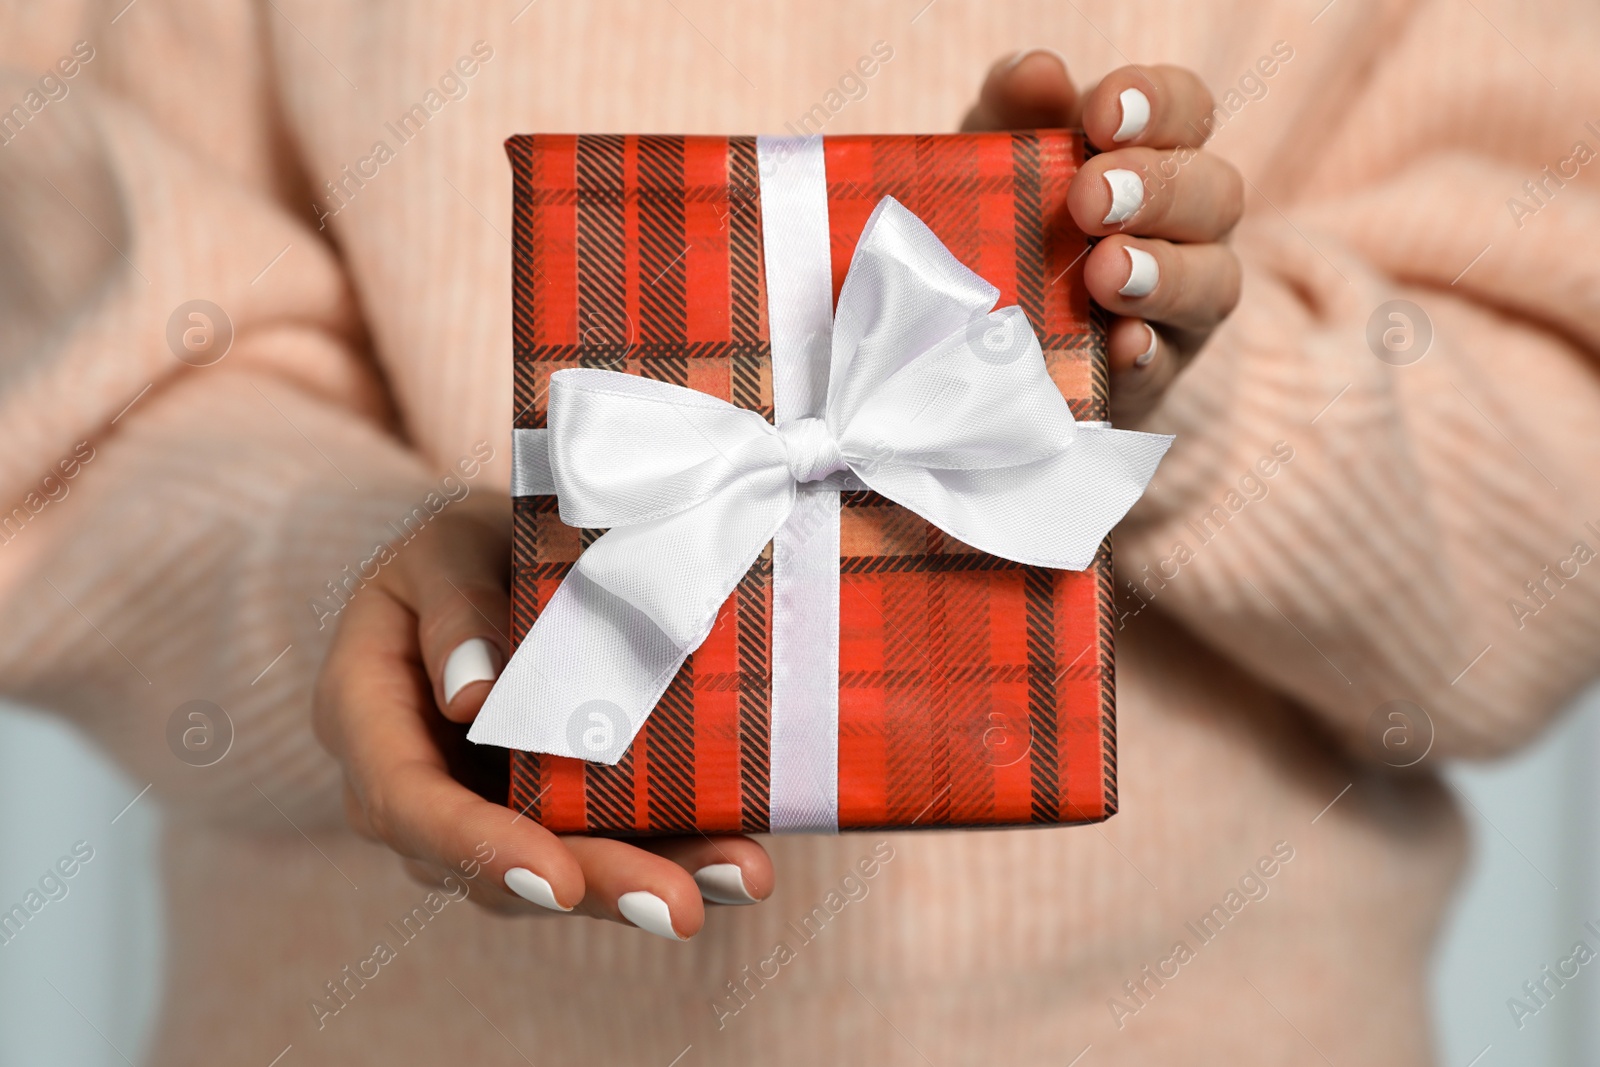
[387,504,510,723]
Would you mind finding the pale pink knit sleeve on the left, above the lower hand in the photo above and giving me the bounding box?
[0,70,448,830]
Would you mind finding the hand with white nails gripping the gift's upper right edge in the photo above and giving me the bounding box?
[962,51,1243,422]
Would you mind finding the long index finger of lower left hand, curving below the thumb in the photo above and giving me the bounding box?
[328,587,586,910]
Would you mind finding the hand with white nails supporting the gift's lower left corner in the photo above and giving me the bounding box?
[314,494,773,941]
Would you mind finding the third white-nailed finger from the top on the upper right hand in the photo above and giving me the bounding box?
[1083,235,1238,331]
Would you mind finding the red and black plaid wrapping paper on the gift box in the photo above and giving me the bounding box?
[506,131,1117,835]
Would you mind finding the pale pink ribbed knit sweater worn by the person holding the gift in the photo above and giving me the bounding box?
[0,0,1600,1067]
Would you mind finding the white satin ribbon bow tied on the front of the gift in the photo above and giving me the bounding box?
[467,197,1171,765]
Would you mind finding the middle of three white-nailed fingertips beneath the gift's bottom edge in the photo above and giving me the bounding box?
[562,837,706,941]
